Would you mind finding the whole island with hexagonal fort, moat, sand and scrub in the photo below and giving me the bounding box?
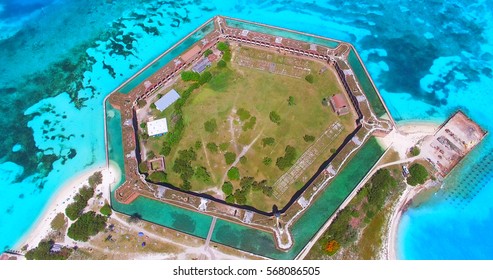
[7,16,487,259]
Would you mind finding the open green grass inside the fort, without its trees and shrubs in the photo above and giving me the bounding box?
[142,47,354,211]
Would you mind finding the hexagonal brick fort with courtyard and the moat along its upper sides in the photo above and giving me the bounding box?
[104,16,394,250]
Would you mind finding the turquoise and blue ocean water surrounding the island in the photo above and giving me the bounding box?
[0,0,493,259]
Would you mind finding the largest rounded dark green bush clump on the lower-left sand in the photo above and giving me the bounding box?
[67,211,106,241]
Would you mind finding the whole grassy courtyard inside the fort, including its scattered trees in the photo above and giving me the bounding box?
[140,47,354,211]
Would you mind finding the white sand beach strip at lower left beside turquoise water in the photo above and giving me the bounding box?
[14,165,121,250]
